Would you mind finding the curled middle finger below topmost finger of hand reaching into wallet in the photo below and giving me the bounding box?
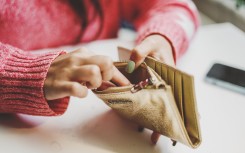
[71,65,102,89]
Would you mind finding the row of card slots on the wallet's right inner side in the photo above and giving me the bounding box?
[145,57,201,148]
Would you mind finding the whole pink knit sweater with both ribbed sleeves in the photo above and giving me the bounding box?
[0,0,198,116]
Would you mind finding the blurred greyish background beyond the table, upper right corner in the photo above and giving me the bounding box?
[193,0,245,31]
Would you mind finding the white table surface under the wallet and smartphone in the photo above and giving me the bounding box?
[0,23,245,153]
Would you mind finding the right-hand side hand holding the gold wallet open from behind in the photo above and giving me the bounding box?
[130,34,175,144]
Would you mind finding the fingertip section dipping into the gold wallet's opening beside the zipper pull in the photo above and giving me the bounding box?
[112,66,131,86]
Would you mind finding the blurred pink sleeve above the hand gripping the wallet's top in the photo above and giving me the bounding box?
[121,0,199,60]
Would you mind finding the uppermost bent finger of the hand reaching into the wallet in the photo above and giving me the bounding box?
[82,55,113,81]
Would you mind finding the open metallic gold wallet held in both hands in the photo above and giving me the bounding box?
[93,57,201,148]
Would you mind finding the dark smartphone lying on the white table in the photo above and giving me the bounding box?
[205,63,245,95]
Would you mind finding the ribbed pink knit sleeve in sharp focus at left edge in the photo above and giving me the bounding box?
[0,42,69,116]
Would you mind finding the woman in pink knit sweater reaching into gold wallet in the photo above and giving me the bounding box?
[0,0,198,142]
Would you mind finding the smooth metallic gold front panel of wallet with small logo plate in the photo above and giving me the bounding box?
[95,85,192,147]
